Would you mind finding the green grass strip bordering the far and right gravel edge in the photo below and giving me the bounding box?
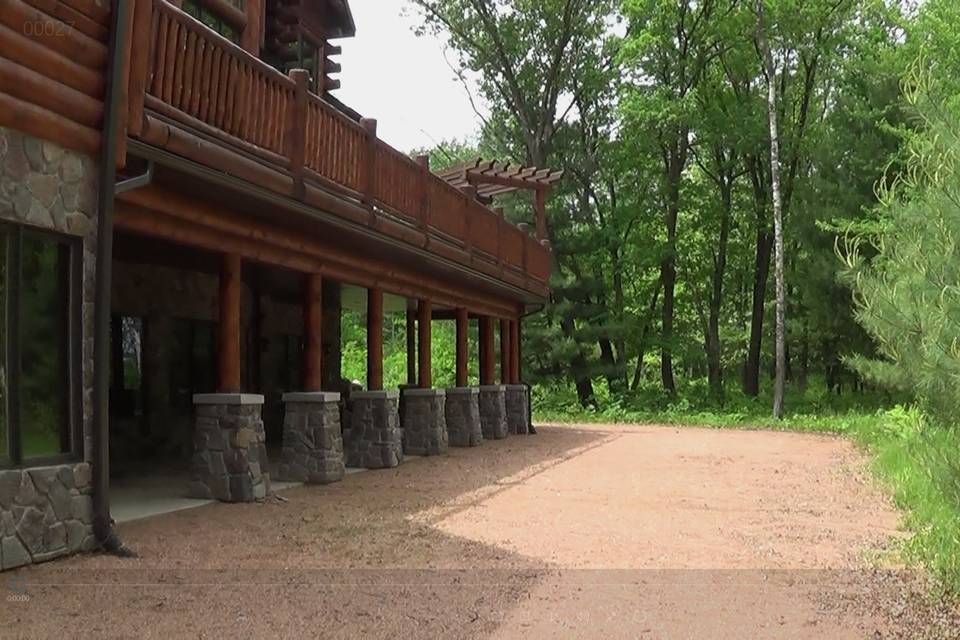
[533,385,960,595]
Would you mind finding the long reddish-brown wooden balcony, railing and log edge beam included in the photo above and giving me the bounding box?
[121,0,552,296]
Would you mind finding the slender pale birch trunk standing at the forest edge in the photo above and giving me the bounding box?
[757,0,787,419]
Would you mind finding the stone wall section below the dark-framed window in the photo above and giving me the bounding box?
[0,462,96,570]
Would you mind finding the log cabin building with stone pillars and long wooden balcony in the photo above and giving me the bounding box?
[0,0,560,569]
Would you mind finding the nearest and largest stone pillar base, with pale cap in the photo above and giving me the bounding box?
[190,393,270,502]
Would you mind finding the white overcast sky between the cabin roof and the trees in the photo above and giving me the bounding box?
[334,0,488,152]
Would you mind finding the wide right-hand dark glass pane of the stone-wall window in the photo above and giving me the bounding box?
[20,233,70,459]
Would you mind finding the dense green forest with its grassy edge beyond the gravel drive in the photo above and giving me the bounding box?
[368,0,960,588]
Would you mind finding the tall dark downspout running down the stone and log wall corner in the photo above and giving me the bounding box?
[91,0,133,557]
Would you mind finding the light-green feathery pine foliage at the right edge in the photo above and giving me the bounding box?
[844,69,960,423]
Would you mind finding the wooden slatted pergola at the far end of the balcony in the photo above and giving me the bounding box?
[437,158,563,240]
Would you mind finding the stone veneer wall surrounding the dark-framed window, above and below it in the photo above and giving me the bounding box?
[0,127,98,569]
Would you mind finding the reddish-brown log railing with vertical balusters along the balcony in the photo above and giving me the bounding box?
[127,0,552,282]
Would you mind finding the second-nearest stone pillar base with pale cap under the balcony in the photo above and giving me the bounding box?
[278,392,344,484]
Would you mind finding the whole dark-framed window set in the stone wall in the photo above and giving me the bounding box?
[0,225,81,465]
